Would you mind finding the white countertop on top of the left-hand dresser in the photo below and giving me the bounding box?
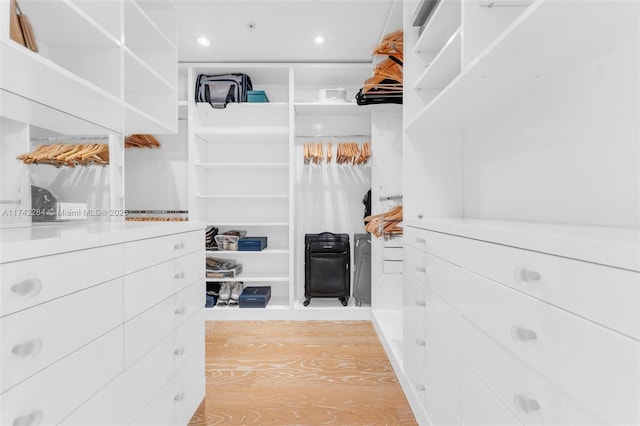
[0,221,206,263]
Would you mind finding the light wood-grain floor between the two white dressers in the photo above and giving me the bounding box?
[189,321,416,426]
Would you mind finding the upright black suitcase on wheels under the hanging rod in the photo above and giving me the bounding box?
[304,232,351,306]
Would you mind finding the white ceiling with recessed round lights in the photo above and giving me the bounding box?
[176,0,401,62]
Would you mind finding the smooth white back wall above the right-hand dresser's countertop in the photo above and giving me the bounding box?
[464,41,640,227]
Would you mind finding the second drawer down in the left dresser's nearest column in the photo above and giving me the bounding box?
[0,278,122,392]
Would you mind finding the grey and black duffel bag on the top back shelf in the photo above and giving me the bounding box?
[195,73,253,108]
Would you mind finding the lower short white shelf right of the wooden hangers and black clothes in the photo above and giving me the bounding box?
[414,28,462,90]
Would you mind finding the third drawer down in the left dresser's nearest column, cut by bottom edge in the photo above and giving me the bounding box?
[0,328,122,425]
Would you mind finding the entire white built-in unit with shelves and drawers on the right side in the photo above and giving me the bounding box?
[398,0,640,424]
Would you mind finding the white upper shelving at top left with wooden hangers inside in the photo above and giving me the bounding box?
[0,0,177,133]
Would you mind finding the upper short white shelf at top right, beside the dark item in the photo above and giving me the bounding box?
[414,0,462,57]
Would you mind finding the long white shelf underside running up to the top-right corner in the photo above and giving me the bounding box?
[406,0,637,134]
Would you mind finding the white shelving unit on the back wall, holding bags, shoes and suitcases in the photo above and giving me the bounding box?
[185,63,371,319]
